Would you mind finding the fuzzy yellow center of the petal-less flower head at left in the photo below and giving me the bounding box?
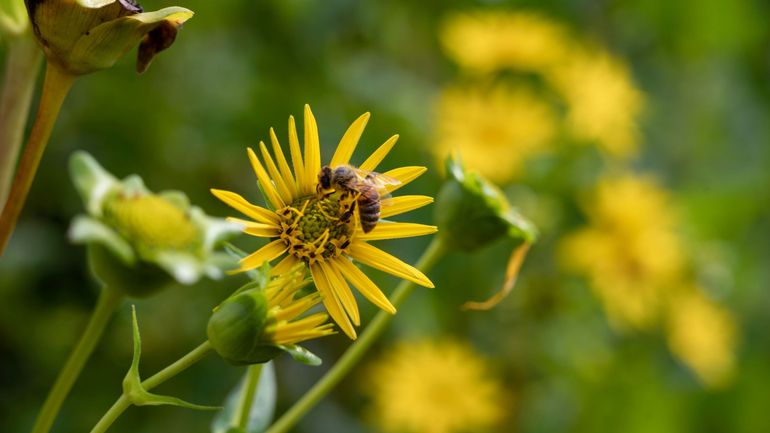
[105,195,197,250]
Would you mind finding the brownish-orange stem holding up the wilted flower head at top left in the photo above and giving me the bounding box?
[0,63,75,255]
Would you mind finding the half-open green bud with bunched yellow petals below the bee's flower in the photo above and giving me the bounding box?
[206,266,333,365]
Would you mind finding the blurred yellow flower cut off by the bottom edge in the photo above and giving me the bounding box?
[365,341,507,433]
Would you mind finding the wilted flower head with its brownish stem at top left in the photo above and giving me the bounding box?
[0,0,193,252]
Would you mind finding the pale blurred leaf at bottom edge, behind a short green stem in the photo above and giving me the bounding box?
[211,361,277,433]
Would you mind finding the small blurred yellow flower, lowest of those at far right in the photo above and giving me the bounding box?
[667,288,736,386]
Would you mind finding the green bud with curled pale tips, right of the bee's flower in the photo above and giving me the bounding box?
[435,157,537,251]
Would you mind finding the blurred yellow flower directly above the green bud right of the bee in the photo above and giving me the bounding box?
[433,85,556,183]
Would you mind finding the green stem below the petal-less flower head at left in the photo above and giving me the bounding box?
[32,288,123,433]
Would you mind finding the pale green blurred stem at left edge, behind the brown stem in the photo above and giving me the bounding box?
[0,31,43,206]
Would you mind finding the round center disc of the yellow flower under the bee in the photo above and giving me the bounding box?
[277,194,355,265]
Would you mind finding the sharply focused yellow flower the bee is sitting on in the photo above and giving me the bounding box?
[212,105,436,339]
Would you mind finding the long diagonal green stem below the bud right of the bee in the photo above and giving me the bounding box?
[265,236,446,433]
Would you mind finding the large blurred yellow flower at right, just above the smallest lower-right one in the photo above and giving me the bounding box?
[560,174,684,329]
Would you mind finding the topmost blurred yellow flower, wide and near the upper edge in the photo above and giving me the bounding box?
[440,11,570,72]
